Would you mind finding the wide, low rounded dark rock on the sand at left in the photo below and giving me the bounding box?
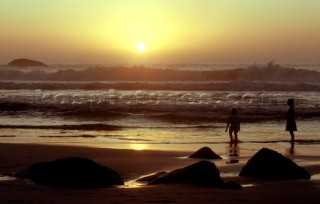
[16,157,124,188]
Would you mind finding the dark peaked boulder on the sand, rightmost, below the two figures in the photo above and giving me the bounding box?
[239,148,310,180]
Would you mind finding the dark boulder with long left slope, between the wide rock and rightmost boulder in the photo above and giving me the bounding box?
[148,161,241,189]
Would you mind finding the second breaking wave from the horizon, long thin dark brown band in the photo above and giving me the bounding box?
[0,80,320,91]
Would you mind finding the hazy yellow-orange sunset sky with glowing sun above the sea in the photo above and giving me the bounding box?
[0,0,320,64]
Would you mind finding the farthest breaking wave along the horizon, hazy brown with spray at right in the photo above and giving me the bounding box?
[0,62,320,86]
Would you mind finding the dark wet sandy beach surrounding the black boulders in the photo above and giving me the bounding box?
[0,143,320,203]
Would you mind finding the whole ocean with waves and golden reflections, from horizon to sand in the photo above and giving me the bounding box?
[0,63,320,155]
